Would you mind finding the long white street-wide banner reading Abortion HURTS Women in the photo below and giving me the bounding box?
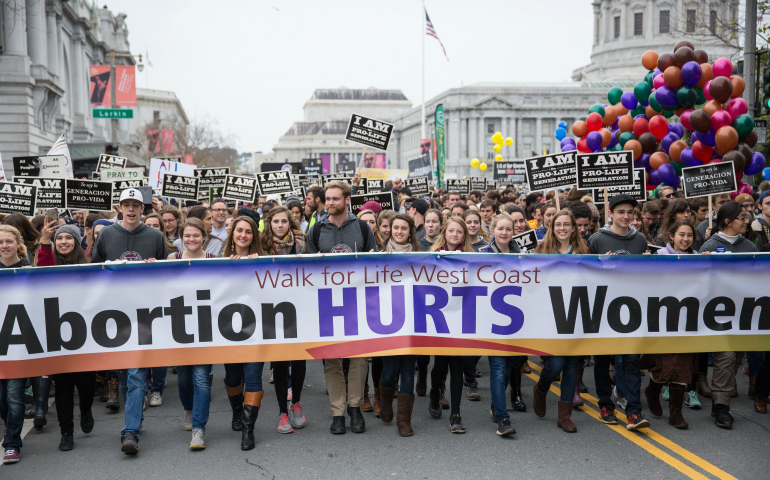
[0,253,770,379]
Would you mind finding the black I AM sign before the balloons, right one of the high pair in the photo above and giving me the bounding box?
[572,154,634,190]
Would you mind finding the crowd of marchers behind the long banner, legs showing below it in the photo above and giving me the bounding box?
[0,176,770,463]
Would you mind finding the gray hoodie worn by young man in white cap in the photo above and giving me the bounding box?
[91,223,168,263]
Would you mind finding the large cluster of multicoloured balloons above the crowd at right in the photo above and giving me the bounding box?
[555,40,765,196]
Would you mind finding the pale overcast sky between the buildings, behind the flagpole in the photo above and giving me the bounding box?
[105,0,593,152]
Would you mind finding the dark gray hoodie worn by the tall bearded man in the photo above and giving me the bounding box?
[307,212,378,253]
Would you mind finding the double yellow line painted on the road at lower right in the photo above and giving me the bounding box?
[527,362,738,480]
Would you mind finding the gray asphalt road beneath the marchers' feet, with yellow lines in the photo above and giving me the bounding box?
[0,357,770,480]
